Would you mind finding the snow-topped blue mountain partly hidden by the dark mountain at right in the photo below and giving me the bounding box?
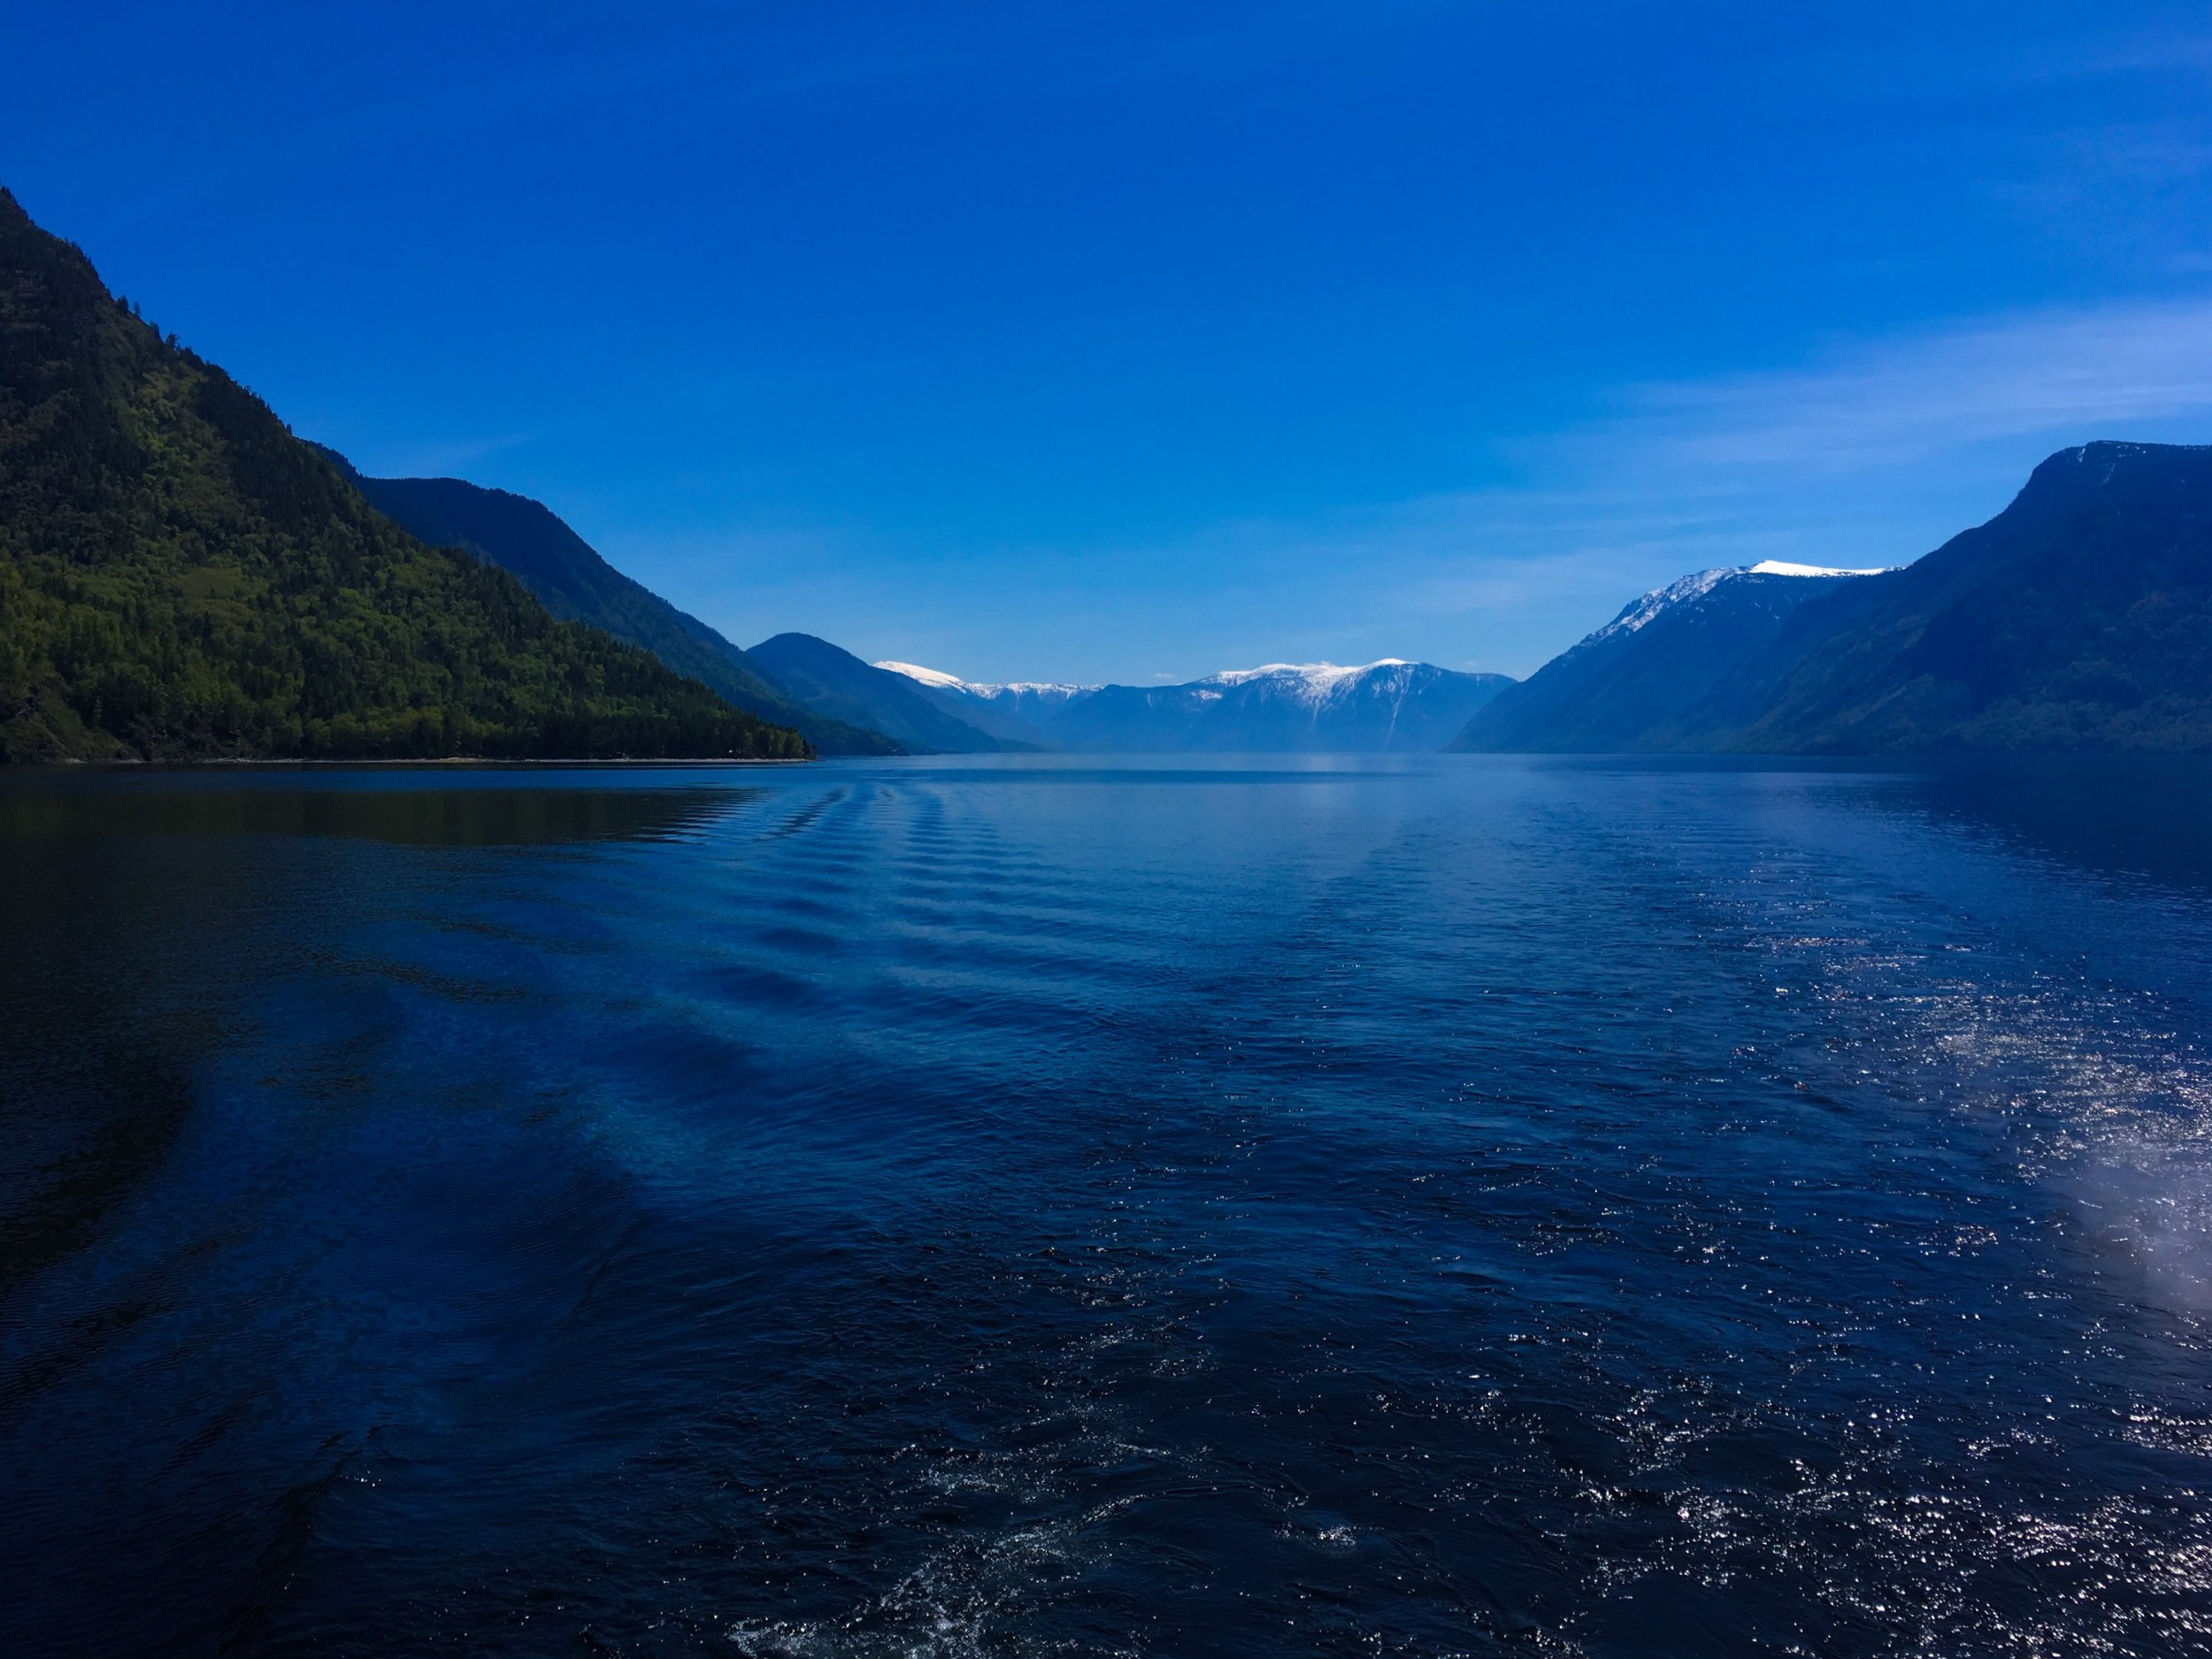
[1451,560,1880,755]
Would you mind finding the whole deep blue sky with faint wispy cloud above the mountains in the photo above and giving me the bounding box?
[0,0,2212,684]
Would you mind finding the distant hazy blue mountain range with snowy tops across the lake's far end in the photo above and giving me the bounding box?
[885,659,1513,755]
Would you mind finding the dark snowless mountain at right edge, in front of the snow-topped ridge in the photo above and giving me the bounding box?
[1463,442,2212,755]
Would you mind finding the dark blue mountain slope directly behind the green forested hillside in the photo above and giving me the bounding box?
[317,462,901,755]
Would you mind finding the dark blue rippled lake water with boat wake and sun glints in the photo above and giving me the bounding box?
[0,759,2212,1657]
